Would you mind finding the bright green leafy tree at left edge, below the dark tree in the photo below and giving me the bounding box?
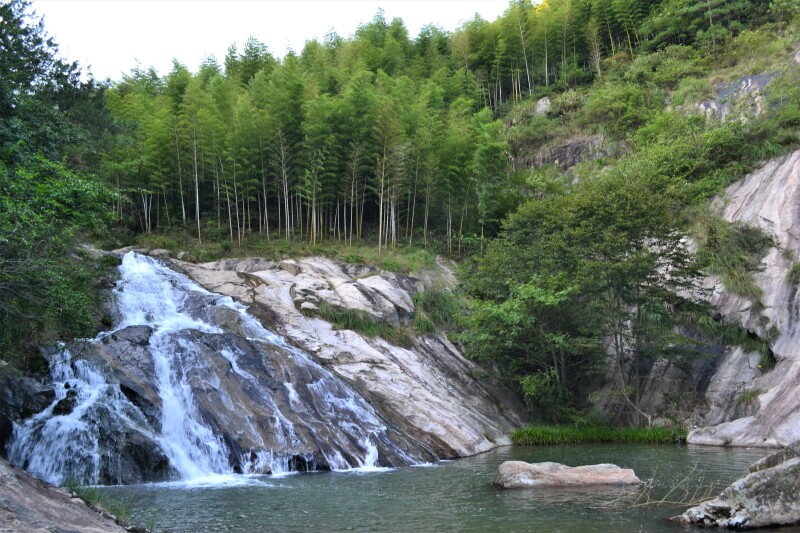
[0,158,112,359]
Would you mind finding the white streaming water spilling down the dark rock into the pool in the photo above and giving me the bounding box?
[9,253,417,483]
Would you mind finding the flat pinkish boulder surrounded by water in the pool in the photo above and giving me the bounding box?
[494,461,641,489]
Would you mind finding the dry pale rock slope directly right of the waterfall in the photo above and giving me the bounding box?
[172,257,522,457]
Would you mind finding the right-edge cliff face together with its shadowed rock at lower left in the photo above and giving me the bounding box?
[628,151,800,446]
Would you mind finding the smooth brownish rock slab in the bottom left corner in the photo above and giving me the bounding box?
[0,459,125,533]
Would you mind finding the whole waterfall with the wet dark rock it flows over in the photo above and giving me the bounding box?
[8,252,430,484]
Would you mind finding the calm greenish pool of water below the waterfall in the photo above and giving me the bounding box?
[108,445,785,533]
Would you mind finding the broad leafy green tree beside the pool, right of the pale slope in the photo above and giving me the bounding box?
[464,169,701,421]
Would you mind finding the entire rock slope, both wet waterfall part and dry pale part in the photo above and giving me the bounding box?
[7,253,522,484]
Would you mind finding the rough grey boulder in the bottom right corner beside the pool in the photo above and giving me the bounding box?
[673,442,800,529]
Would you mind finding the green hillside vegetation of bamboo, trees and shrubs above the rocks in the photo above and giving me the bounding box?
[0,0,800,424]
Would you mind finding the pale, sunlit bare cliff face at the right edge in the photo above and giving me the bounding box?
[689,151,800,446]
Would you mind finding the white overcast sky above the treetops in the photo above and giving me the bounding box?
[32,0,508,81]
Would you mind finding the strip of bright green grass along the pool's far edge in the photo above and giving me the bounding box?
[511,426,686,446]
